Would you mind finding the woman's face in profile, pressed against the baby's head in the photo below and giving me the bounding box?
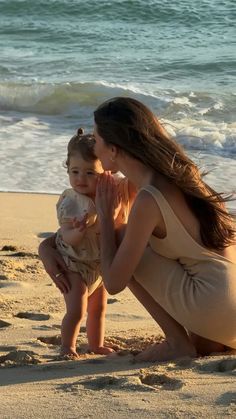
[93,124,118,172]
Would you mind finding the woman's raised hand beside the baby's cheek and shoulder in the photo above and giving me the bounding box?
[95,172,121,220]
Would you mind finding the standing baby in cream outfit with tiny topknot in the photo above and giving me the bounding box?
[56,128,129,358]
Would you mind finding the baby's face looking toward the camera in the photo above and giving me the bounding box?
[68,154,103,198]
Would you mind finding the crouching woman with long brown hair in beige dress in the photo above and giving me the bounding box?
[39,98,236,361]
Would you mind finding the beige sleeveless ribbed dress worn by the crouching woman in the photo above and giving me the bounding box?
[134,185,236,349]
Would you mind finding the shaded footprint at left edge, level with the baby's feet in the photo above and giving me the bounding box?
[0,350,42,367]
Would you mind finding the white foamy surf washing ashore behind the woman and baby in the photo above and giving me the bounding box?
[0,106,236,207]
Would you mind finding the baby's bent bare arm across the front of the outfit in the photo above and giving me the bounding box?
[61,214,87,246]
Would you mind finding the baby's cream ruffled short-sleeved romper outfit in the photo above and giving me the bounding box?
[56,175,129,295]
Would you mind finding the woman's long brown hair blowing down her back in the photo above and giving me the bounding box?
[94,97,235,250]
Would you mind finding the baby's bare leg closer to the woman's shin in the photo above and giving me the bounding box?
[86,285,114,355]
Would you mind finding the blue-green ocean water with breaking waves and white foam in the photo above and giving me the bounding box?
[0,0,236,209]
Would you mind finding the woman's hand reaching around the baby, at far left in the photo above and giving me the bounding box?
[39,236,71,294]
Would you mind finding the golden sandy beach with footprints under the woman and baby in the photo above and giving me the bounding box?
[0,193,236,419]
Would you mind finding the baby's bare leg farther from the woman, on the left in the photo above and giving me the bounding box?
[61,272,88,356]
